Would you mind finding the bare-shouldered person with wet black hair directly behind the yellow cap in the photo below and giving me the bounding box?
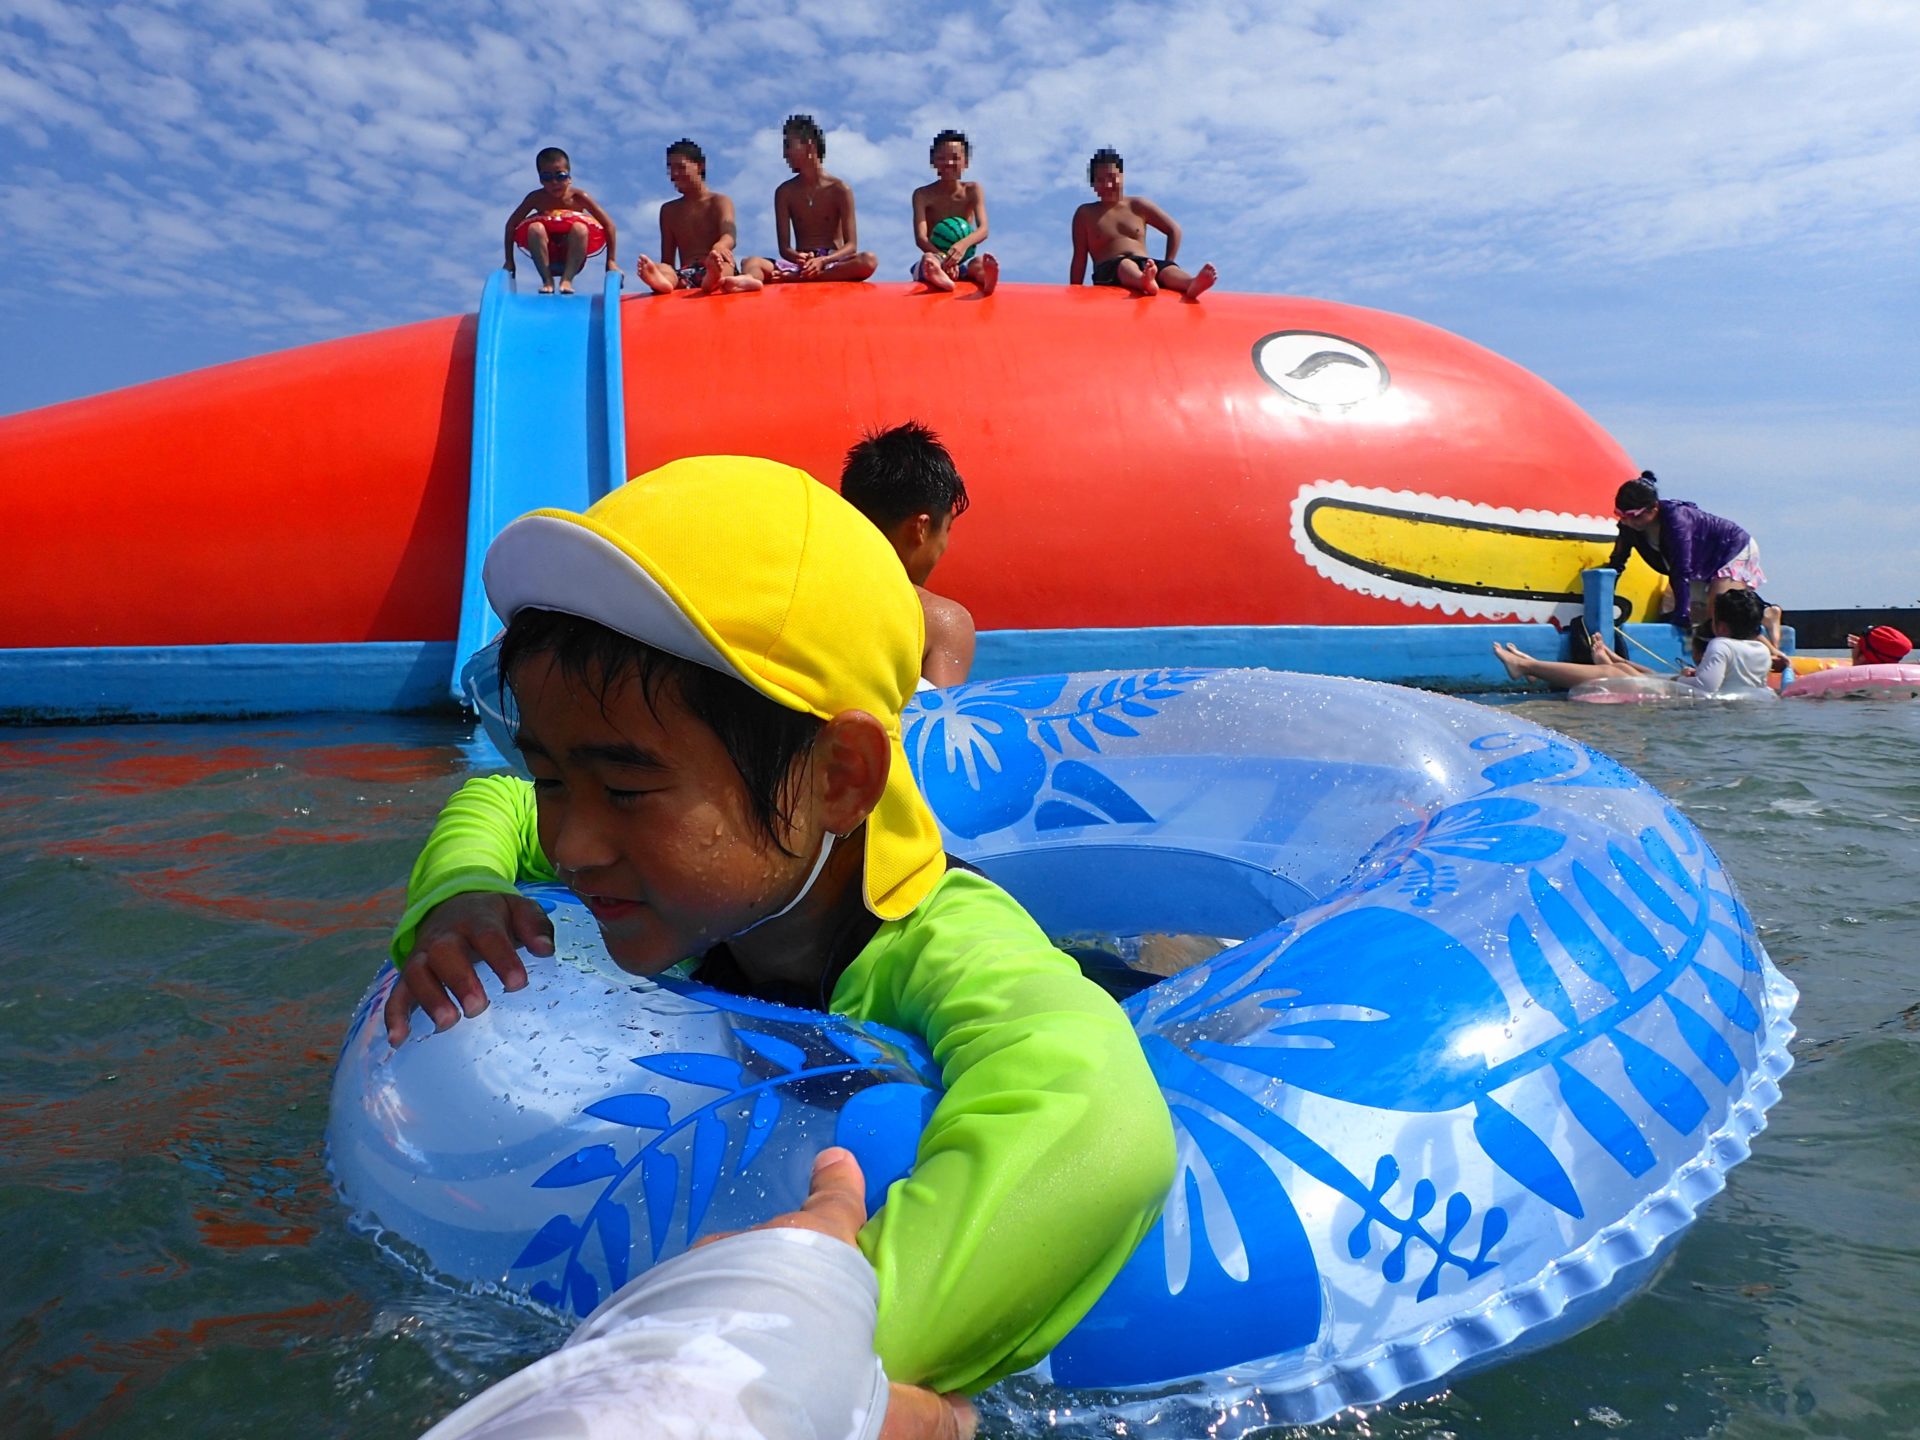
[841,422,987,687]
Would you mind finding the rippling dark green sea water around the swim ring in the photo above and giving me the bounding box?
[0,701,1920,1440]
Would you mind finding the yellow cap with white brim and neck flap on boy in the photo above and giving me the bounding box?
[484,455,947,920]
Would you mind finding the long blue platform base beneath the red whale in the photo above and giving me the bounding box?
[0,624,1743,724]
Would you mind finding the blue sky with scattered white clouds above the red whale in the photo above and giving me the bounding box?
[11,0,1920,607]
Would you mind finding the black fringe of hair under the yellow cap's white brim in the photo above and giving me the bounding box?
[499,609,826,854]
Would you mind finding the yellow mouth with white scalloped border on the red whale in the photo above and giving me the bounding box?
[1292,480,1665,620]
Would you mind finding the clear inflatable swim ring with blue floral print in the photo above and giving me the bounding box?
[328,670,1797,1434]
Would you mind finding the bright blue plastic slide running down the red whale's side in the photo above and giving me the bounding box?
[447,271,626,699]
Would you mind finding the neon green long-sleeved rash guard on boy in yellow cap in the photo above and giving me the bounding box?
[392,776,1173,1390]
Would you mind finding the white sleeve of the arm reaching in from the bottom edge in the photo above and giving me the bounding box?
[422,1229,887,1440]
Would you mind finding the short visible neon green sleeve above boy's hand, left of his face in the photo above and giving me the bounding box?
[388,776,555,966]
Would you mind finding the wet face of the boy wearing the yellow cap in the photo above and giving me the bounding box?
[511,655,818,975]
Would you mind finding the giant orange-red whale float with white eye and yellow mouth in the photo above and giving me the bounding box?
[0,280,1657,712]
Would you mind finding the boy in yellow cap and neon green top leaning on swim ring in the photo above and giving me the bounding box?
[386,457,1173,1390]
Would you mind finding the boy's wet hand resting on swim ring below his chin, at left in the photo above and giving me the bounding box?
[384,891,553,1048]
